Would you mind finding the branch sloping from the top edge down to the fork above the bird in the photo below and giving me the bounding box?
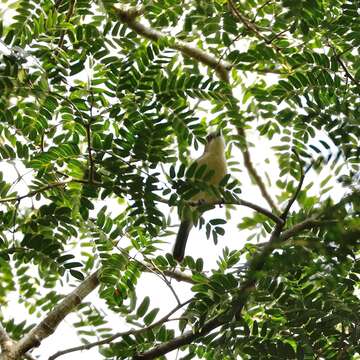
[114,5,232,82]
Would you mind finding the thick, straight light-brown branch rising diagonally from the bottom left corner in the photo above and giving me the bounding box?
[16,270,99,356]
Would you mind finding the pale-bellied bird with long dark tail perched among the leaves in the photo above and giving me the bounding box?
[173,130,227,263]
